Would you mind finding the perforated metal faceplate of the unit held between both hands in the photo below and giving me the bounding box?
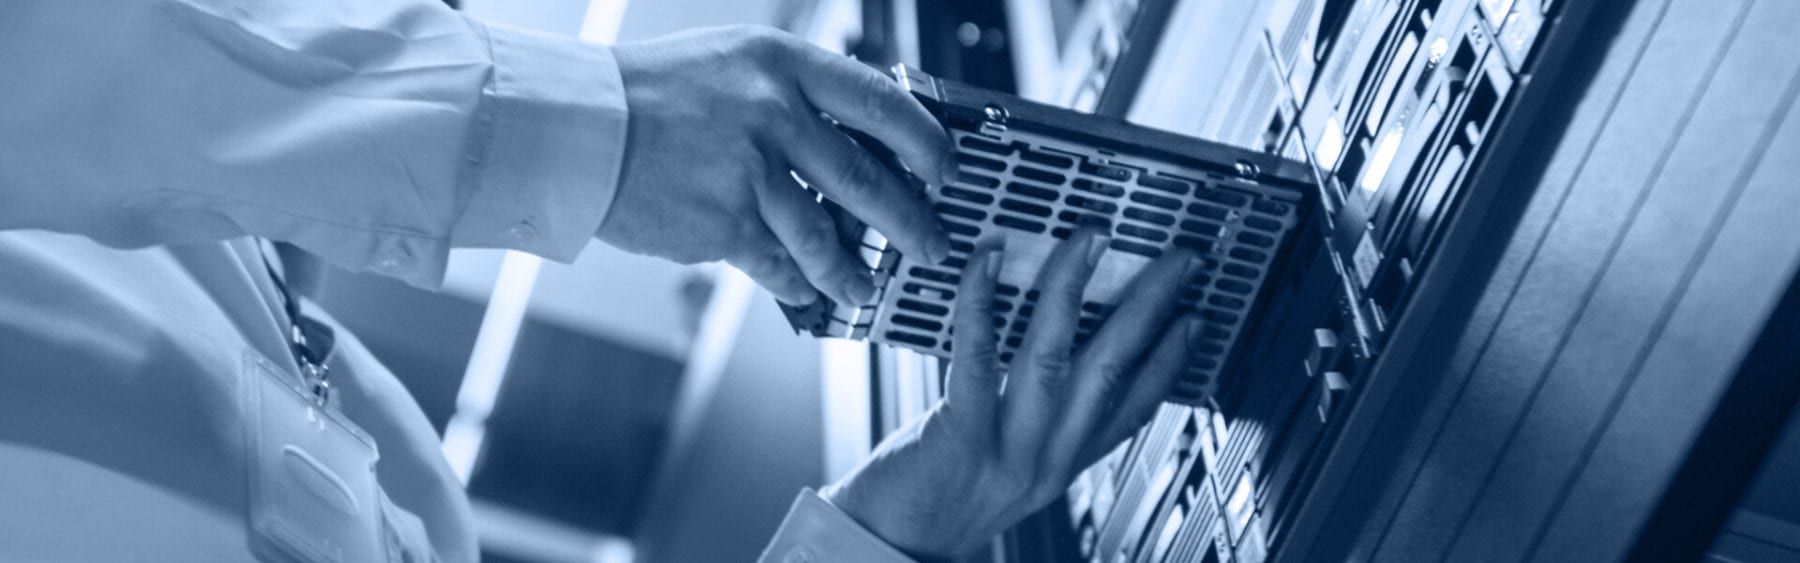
[774,67,1307,403]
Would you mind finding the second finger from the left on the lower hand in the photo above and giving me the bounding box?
[1004,228,1111,450]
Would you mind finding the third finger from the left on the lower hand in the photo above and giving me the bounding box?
[1049,250,1199,462]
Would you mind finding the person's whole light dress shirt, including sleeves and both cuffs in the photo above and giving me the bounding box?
[0,0,905,561]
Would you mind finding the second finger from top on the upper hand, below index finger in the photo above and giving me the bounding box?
[785,117,950,264]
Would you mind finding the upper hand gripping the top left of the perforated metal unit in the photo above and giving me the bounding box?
[598,27,956,304]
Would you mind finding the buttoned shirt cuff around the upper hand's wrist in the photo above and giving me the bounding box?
[450,18,626,263]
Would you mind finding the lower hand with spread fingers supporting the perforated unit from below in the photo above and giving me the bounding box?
[824,230,1201,558]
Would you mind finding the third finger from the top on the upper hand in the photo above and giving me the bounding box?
[758,165,875,306]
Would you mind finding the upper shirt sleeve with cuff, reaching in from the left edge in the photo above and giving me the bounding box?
[0,0,626,288]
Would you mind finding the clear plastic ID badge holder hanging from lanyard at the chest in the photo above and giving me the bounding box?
[241,353,389,563]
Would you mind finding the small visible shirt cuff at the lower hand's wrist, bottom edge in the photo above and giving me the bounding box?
[758,489,913,563]
